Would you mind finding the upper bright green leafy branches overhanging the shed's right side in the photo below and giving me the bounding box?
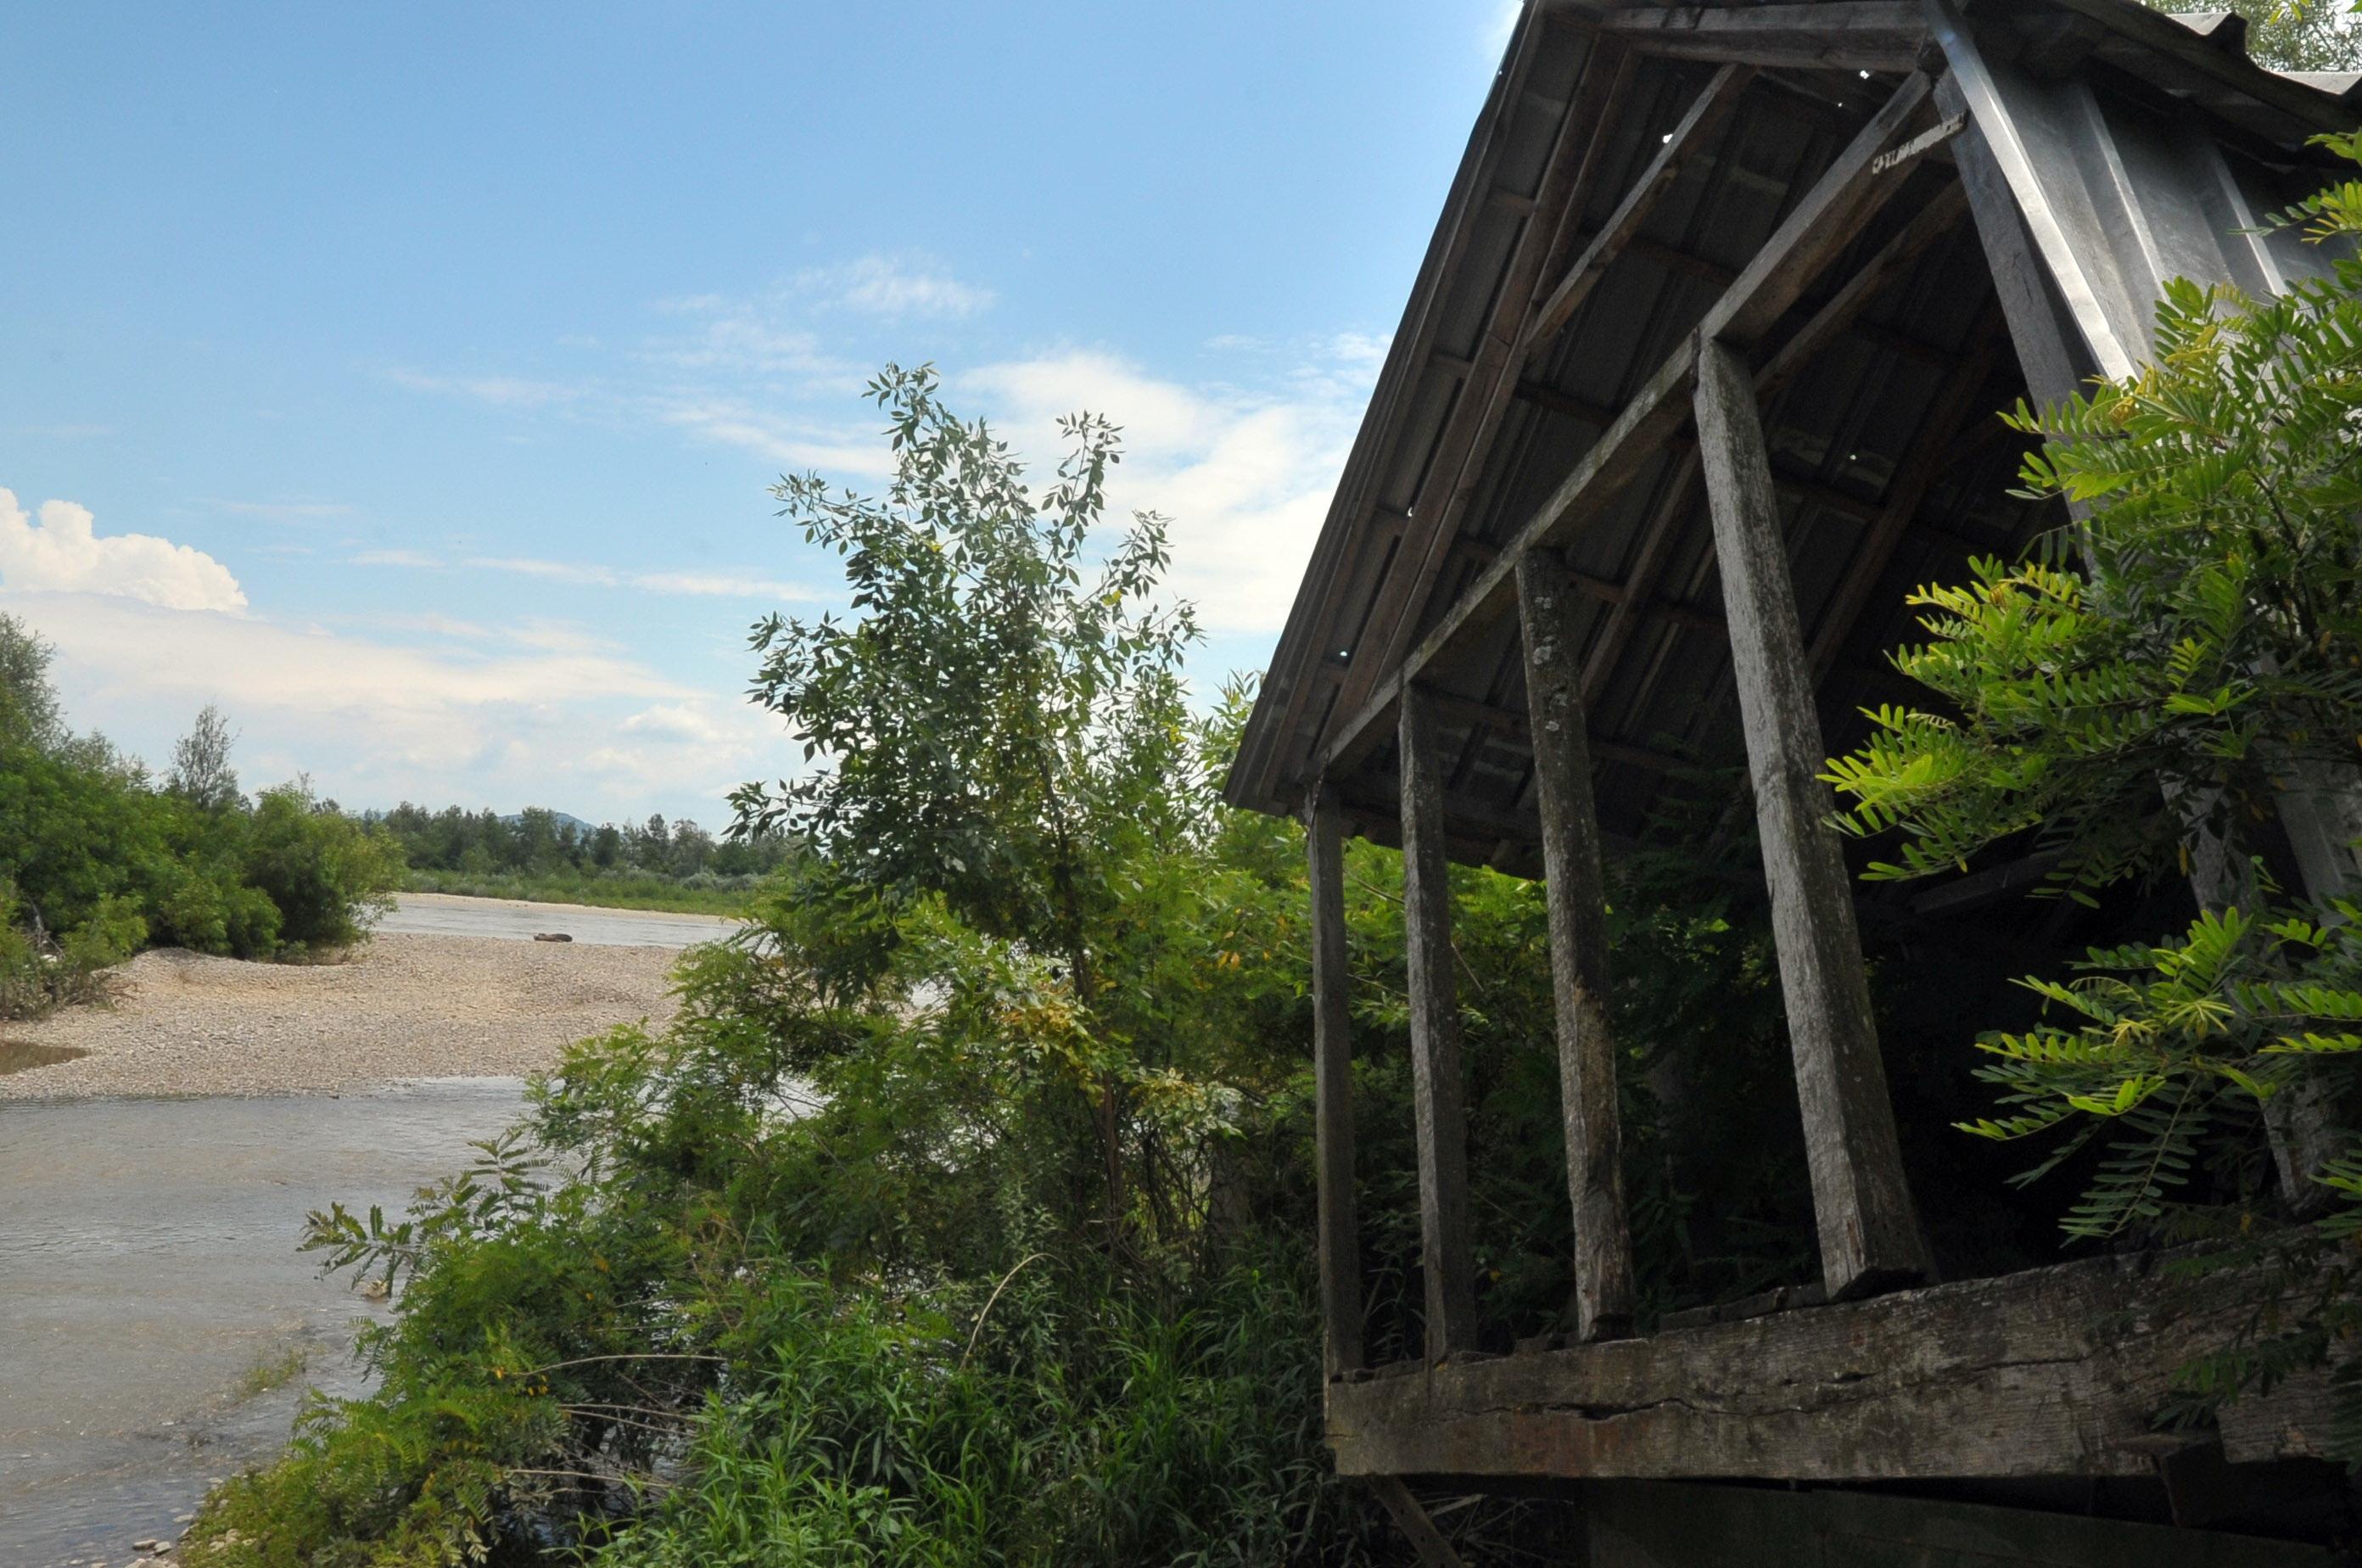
[1826,260,2362,899]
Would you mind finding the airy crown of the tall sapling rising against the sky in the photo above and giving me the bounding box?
[735,366,1197,987]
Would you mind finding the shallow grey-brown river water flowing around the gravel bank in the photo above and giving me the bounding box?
[0,898,725,1568]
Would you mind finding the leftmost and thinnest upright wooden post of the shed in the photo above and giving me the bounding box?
[1304,787,1363,1379]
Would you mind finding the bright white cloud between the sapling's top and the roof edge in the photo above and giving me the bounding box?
[959,340,1374,633]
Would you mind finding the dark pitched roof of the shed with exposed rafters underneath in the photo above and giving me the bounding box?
[1229,0,2353,866]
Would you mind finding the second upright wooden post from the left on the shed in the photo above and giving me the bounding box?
[1401,685,1476,1363]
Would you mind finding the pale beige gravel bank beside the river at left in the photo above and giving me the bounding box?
[0,932,680,1100]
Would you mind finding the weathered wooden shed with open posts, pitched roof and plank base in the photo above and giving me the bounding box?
[1229,0,2357,1561]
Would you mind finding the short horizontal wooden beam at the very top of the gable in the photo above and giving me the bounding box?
[1599,0,1928,73]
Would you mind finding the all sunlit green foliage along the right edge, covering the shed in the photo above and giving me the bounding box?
[1823,137,2362,1464]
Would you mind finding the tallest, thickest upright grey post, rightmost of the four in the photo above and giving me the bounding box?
[1696,340,1928,1299]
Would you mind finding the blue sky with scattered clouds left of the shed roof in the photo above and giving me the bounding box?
[0,0,1514,824]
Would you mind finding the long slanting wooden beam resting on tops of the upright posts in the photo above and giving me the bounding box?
[1316,76,1928,777]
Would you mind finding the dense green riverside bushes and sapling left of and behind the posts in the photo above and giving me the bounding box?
[192,373,1810,1568]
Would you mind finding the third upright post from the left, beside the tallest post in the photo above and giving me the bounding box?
[1516,550,1632,1341]
